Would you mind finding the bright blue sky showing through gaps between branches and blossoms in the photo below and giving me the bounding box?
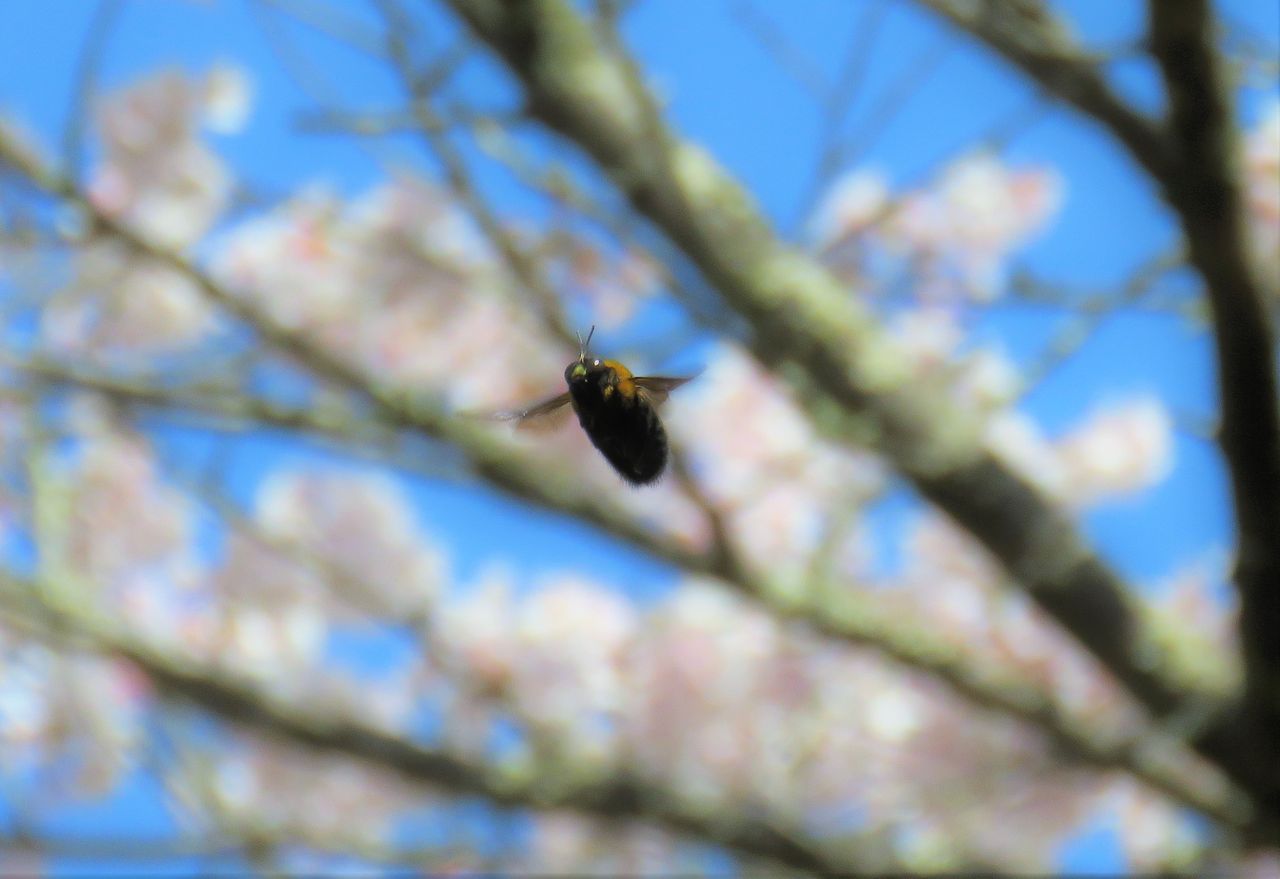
[0,0,1277,871]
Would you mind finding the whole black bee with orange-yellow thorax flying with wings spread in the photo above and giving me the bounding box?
[493,326,692,485]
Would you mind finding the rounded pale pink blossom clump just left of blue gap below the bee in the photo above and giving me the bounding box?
[202,471,448,696]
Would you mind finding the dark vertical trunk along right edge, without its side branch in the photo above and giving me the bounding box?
[1148,0,1280,838]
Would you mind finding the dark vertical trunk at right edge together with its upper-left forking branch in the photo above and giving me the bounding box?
[919,0,1280,838]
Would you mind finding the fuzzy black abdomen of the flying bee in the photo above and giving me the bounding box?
[573,386,667,485]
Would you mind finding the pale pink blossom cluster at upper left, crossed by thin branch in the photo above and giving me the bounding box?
[42,68,248,357]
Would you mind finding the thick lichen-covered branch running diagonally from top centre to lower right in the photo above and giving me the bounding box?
[437,0,1269,834]
